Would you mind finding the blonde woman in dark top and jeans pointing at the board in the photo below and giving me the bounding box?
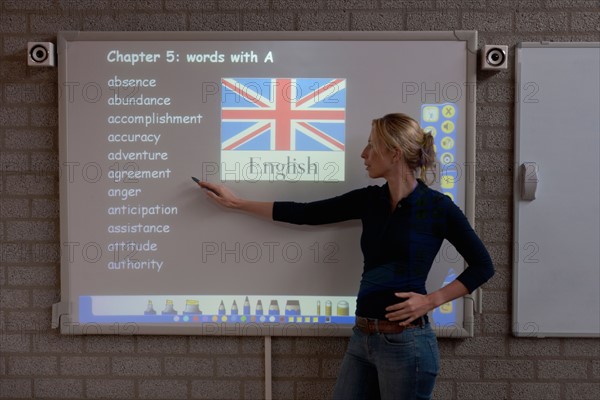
[200,113,494,400]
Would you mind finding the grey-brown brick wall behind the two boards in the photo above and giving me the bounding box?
[0,0,600,400]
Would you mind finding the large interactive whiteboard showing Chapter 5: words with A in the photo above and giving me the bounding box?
[54,32,477,336]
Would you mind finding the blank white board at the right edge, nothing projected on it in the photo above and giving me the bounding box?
[513,43,600,337]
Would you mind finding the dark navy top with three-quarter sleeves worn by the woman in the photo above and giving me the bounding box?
[273,180,494,319]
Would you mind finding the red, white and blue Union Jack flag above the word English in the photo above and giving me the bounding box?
[221,78,346,151]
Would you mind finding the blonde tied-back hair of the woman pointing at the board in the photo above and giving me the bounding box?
[371,113,436,181]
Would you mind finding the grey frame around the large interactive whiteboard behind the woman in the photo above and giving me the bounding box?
[52,30,481,338]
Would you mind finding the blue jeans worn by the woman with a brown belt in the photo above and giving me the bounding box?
[333,323,440,400]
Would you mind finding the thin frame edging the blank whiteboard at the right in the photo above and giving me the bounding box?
[511,42,600,338]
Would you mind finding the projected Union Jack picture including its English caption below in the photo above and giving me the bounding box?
[221,78,346,182]
